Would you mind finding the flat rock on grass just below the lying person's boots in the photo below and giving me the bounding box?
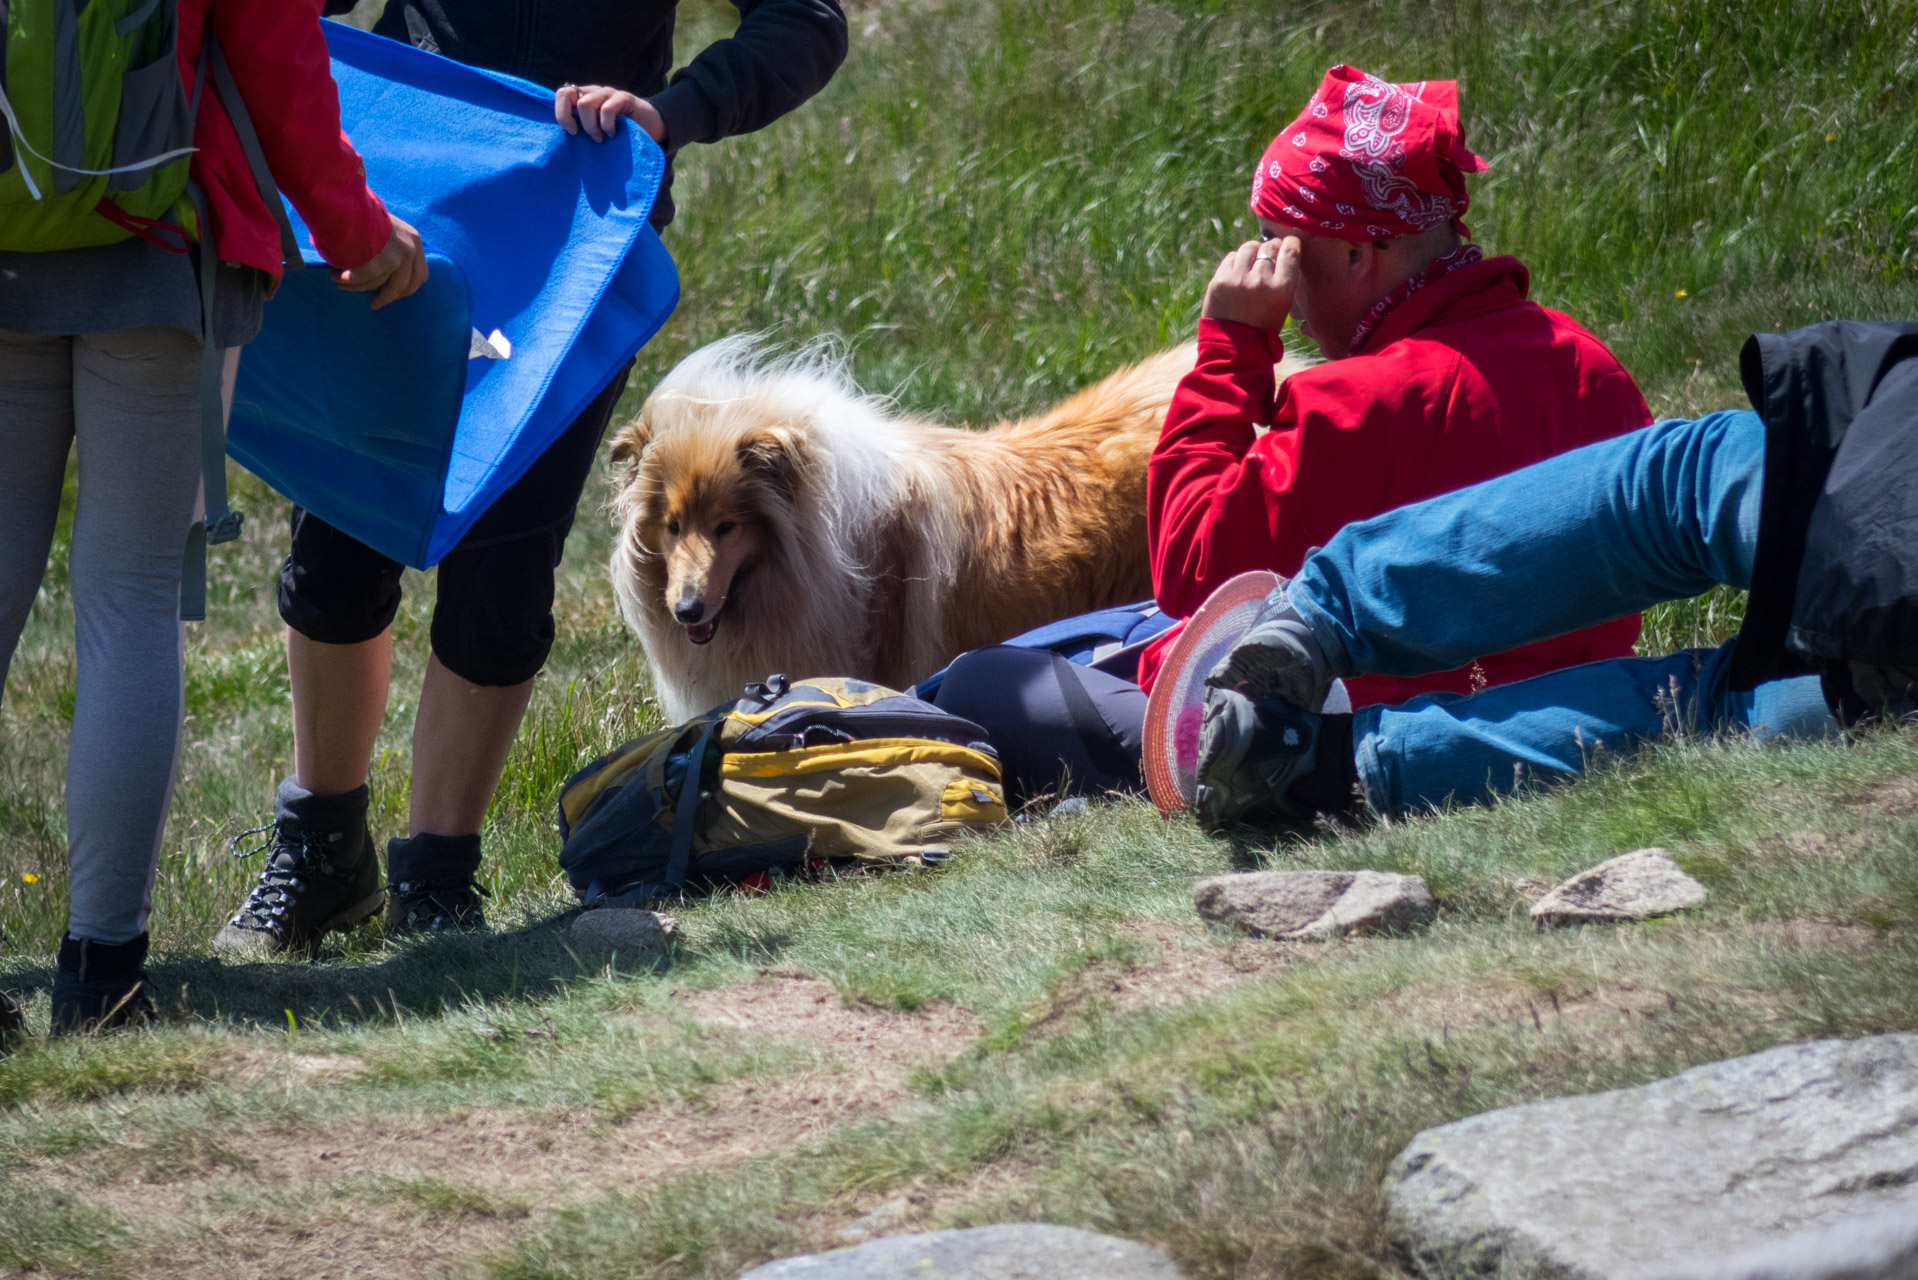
[1195,871,1439,938]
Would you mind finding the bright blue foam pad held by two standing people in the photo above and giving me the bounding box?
[226,23,679,568]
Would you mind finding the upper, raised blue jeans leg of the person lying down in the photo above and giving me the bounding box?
[1289,411,1765,676]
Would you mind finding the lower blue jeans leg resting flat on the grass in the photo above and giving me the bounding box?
[1352,643,1837,816]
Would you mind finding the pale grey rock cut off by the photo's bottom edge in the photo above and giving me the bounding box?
[738,1222,1183,1280]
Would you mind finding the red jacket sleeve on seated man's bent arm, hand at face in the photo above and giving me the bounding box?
[1145,320,1423,618]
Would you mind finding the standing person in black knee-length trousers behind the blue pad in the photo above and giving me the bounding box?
[215,0,846,952]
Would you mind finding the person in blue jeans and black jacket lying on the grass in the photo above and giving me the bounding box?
[1195,320,1918,827]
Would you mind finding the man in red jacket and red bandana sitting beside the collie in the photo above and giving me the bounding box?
[936,67,1651,798]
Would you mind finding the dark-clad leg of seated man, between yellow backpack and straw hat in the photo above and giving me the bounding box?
[932,645,1145,808]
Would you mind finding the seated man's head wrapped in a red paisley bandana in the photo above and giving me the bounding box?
[1252,67,1485,359]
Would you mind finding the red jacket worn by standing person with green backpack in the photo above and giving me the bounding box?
[180,0,393,278]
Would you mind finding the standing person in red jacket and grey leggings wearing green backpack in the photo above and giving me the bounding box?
[0,0,426,1034]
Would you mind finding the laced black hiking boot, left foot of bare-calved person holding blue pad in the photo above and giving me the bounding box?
[213,779,386,954]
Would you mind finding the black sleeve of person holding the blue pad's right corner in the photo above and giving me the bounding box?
[652,0,846,152]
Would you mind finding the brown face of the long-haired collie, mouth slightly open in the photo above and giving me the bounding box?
[612,403,798,645]
